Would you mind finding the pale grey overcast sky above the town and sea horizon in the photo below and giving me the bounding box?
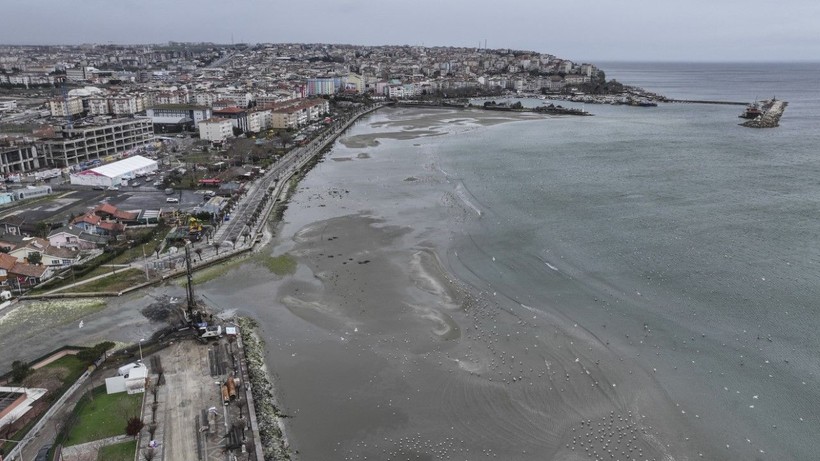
[0,0,820,62]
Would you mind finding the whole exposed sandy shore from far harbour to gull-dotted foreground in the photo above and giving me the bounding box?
[202,106,740,460]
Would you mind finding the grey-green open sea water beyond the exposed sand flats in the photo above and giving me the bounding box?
[446,63,820,459]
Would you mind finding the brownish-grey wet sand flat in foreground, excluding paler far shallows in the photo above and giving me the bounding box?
[234,209,708,460]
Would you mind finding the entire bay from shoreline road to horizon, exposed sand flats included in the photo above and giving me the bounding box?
[203,65,820,460]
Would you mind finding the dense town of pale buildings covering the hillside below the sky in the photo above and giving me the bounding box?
[0,43,599,178]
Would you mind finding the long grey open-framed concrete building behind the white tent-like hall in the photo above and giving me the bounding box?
[42,117,154,167]
